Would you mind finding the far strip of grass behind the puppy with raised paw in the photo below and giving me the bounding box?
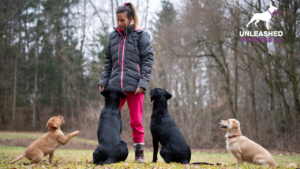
[0,132,98,144]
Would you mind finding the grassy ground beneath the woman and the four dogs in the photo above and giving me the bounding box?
[0,132,300,169]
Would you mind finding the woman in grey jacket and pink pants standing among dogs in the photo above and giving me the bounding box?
[98,2,154,162]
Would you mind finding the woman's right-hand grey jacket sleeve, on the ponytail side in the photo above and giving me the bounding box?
[138,31,154,90]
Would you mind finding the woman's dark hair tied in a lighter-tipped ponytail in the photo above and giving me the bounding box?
[116,2,139,30]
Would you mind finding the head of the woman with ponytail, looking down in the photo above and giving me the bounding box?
[116,2,138,31]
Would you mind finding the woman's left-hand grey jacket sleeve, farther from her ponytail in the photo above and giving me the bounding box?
[98,35,112,87]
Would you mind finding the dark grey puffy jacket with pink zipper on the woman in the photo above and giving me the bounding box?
[98,25,154,92]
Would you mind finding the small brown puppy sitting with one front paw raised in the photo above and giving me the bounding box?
[10,115,79,164]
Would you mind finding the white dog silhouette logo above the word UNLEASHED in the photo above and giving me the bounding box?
[246,2,280,30]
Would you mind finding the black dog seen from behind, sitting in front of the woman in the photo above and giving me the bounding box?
[93,85,128,165]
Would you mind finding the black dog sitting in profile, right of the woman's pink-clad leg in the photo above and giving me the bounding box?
[150,88,191,164]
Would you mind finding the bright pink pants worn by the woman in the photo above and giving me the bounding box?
[120,91,145,143]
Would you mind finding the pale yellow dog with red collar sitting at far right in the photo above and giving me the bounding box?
[220,119,277,166]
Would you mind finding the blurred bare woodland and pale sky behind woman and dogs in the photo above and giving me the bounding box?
[0,0,300,151]
